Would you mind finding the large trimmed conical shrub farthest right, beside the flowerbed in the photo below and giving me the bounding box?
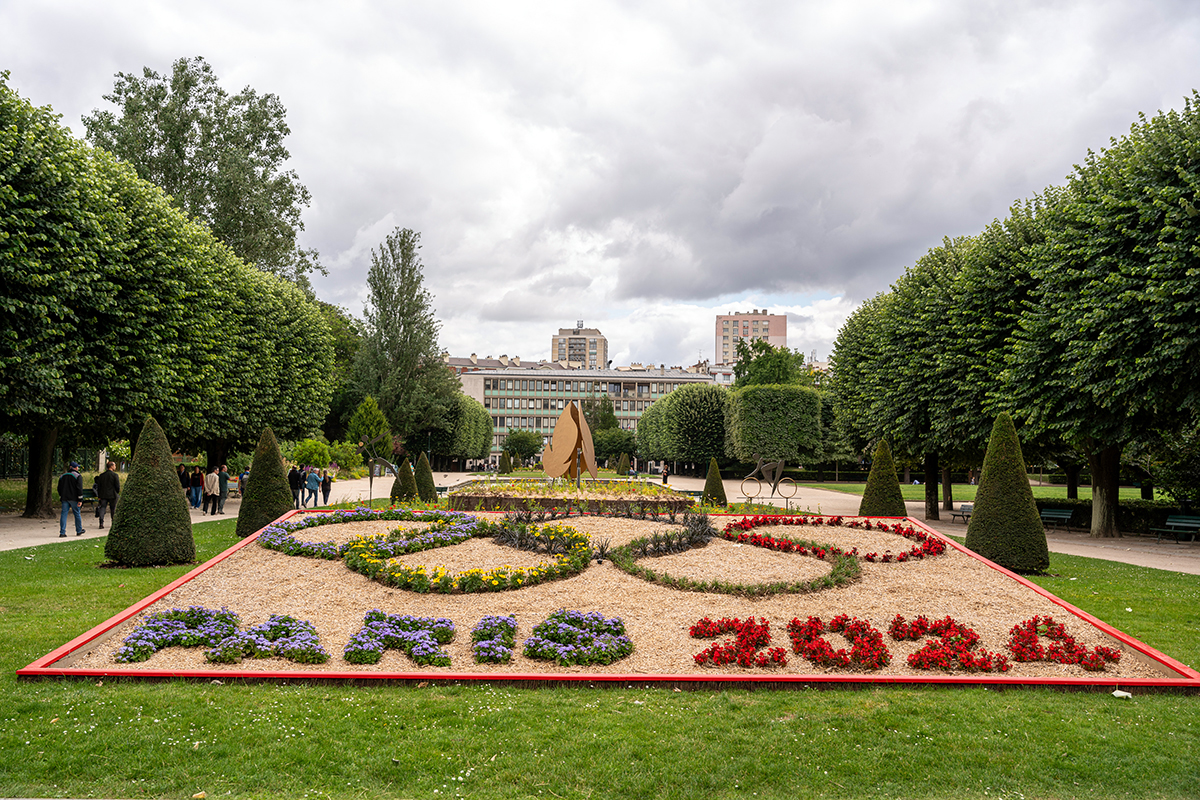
[966,413,1050,572]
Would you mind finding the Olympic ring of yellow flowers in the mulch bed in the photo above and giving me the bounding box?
[346,518,592,594]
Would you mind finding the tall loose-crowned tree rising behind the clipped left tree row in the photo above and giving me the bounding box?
[83,56,320,282]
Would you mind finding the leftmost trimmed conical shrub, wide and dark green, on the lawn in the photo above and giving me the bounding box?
[104,417,196,566]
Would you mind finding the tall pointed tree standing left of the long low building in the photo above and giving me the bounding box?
[358,228,461,448]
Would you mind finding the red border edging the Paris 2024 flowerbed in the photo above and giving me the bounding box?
[17,510,1200,691]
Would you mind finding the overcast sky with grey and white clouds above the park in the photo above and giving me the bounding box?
[0,0,1200,365]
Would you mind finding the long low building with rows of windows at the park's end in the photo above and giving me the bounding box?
[461,367,713,461]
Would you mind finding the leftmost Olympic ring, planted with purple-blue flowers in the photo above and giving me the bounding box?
[258,509,484,560]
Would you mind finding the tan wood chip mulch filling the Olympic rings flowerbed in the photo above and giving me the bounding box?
[65,517,1164,678]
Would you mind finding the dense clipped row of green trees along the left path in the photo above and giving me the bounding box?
[0,80,329,516]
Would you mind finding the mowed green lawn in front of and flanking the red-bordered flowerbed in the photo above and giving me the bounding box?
[0,519,1200,799]
